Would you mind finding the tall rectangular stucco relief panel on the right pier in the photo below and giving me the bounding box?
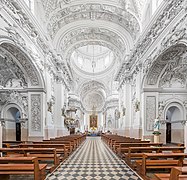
[145,96,156,131]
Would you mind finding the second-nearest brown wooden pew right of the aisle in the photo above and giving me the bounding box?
[136,153,187,177]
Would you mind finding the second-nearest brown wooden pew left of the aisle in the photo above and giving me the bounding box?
[0,148,60,172]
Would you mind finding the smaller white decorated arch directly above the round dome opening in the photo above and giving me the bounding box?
[53,22,133,52]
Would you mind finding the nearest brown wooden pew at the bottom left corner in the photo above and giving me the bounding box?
[0,157,47,180]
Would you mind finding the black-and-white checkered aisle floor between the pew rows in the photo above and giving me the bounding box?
[47,137,141,180]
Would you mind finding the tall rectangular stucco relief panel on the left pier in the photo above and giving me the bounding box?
[31,94,42,132]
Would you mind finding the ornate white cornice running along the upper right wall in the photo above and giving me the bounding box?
[116,0,184,82]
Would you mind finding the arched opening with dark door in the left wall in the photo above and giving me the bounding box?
[5,107,21,141]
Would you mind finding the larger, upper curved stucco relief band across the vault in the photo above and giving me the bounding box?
[47,3,140,39]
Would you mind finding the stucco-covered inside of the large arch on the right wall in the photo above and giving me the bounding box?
[143,44,187,87]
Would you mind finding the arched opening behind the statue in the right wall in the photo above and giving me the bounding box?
[166,106,184,143]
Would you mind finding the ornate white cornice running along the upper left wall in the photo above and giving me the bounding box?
[0,0,71,87]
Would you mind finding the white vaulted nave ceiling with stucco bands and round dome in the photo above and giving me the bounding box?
[41,0,143,110]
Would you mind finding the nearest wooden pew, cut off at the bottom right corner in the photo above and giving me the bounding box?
[153,167,187,180]
